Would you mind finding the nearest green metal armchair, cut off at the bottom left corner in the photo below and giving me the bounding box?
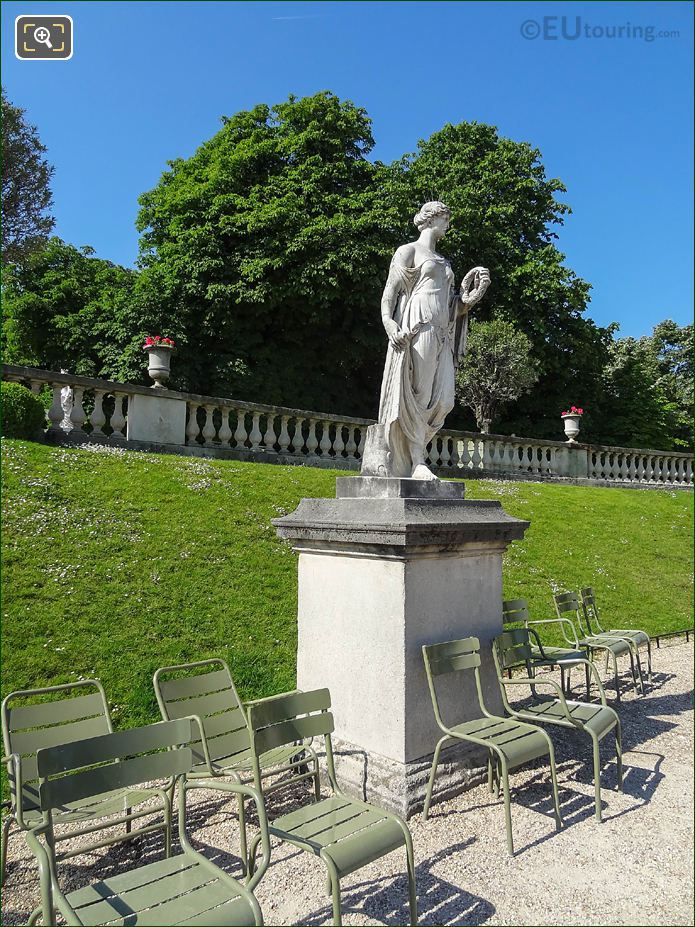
[27,718,270,927]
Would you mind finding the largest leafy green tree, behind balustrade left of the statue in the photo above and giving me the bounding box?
[137,92,400,413]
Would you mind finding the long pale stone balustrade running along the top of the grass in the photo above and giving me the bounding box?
[3,364,693,488]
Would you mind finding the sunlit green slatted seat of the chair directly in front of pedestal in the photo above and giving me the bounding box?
[268,795,405,878]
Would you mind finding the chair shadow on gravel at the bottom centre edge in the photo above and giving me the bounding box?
[302,838,496,927]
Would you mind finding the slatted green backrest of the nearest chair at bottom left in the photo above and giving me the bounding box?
[37,718,196,816]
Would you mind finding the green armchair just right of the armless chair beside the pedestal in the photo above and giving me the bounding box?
[492,628,623,821]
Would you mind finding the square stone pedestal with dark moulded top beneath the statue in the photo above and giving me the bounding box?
[273,477,529,816]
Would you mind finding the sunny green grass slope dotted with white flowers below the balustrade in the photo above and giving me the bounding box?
[2,441,693,725]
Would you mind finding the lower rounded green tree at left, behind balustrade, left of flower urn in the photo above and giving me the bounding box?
[3,238,141,382]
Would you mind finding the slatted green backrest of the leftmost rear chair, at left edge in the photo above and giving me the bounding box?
[1,679,113,812]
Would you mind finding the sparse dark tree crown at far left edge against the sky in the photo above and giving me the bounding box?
[2,88,55,264]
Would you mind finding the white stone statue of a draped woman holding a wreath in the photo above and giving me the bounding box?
[362,201,490,480]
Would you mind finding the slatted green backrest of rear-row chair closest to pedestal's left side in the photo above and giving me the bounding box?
[154,660,251,771]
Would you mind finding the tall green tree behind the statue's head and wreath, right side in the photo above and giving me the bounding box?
[392,122,611,437]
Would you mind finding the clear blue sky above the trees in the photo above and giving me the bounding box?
[2,0,693,337]
